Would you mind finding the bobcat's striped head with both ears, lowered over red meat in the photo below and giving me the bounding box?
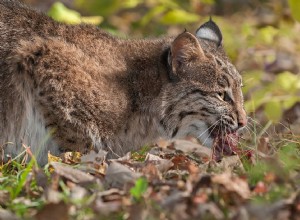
[160,20,247,157]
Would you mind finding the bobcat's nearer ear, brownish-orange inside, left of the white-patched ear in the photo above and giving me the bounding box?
[168,32,205,74]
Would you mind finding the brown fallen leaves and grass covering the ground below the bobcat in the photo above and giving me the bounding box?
[0,138,300,220]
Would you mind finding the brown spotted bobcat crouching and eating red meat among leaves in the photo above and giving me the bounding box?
[0,0,247,164]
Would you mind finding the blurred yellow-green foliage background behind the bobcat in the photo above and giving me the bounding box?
[24,0,300,136]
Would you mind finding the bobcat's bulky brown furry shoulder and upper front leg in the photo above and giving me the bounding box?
[10,38,128,162]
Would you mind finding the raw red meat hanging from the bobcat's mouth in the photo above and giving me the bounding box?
[213,131,239,161]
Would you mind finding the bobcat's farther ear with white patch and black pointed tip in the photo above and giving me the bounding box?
[196,18,223,46]
